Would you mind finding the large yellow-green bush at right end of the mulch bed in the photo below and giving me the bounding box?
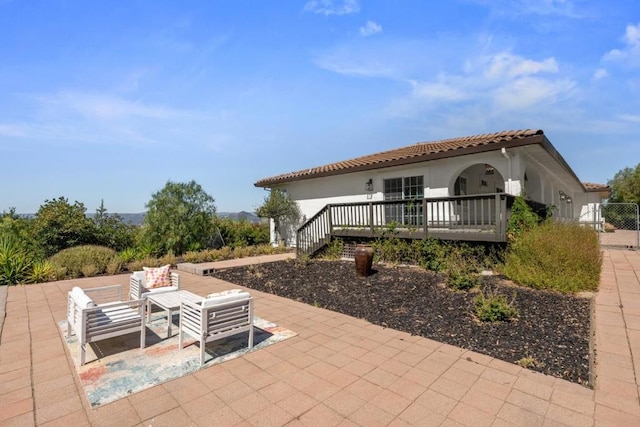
[501,221,602,293]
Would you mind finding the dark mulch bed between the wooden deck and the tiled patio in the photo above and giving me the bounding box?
[215,261,591,385]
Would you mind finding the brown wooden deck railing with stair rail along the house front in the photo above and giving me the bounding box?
[296,193,524,254]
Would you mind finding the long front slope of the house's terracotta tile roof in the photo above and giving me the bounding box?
[255,129,544,187]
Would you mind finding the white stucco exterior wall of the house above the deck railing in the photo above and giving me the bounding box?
[272,148,600,246]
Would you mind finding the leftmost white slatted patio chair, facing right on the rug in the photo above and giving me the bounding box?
[67,285,146,366]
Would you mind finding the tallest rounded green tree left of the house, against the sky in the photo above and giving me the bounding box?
[143,180,216,255]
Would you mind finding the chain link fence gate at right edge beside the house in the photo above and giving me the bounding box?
[596,203,640,248]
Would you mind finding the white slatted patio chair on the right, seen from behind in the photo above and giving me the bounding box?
[179,289,253,366]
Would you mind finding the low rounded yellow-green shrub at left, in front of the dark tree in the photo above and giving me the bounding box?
[49,245,118,277]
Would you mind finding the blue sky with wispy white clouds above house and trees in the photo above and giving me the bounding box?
[0,0,640,213]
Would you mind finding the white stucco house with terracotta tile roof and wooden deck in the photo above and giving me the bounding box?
[255,130,609,251]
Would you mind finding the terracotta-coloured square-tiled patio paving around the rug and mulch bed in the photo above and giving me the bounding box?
[0,250,640,426]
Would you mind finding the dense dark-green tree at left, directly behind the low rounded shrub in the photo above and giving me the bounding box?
[32,197,93,256]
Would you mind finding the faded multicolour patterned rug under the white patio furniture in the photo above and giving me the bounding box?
[58,312,297,408]
